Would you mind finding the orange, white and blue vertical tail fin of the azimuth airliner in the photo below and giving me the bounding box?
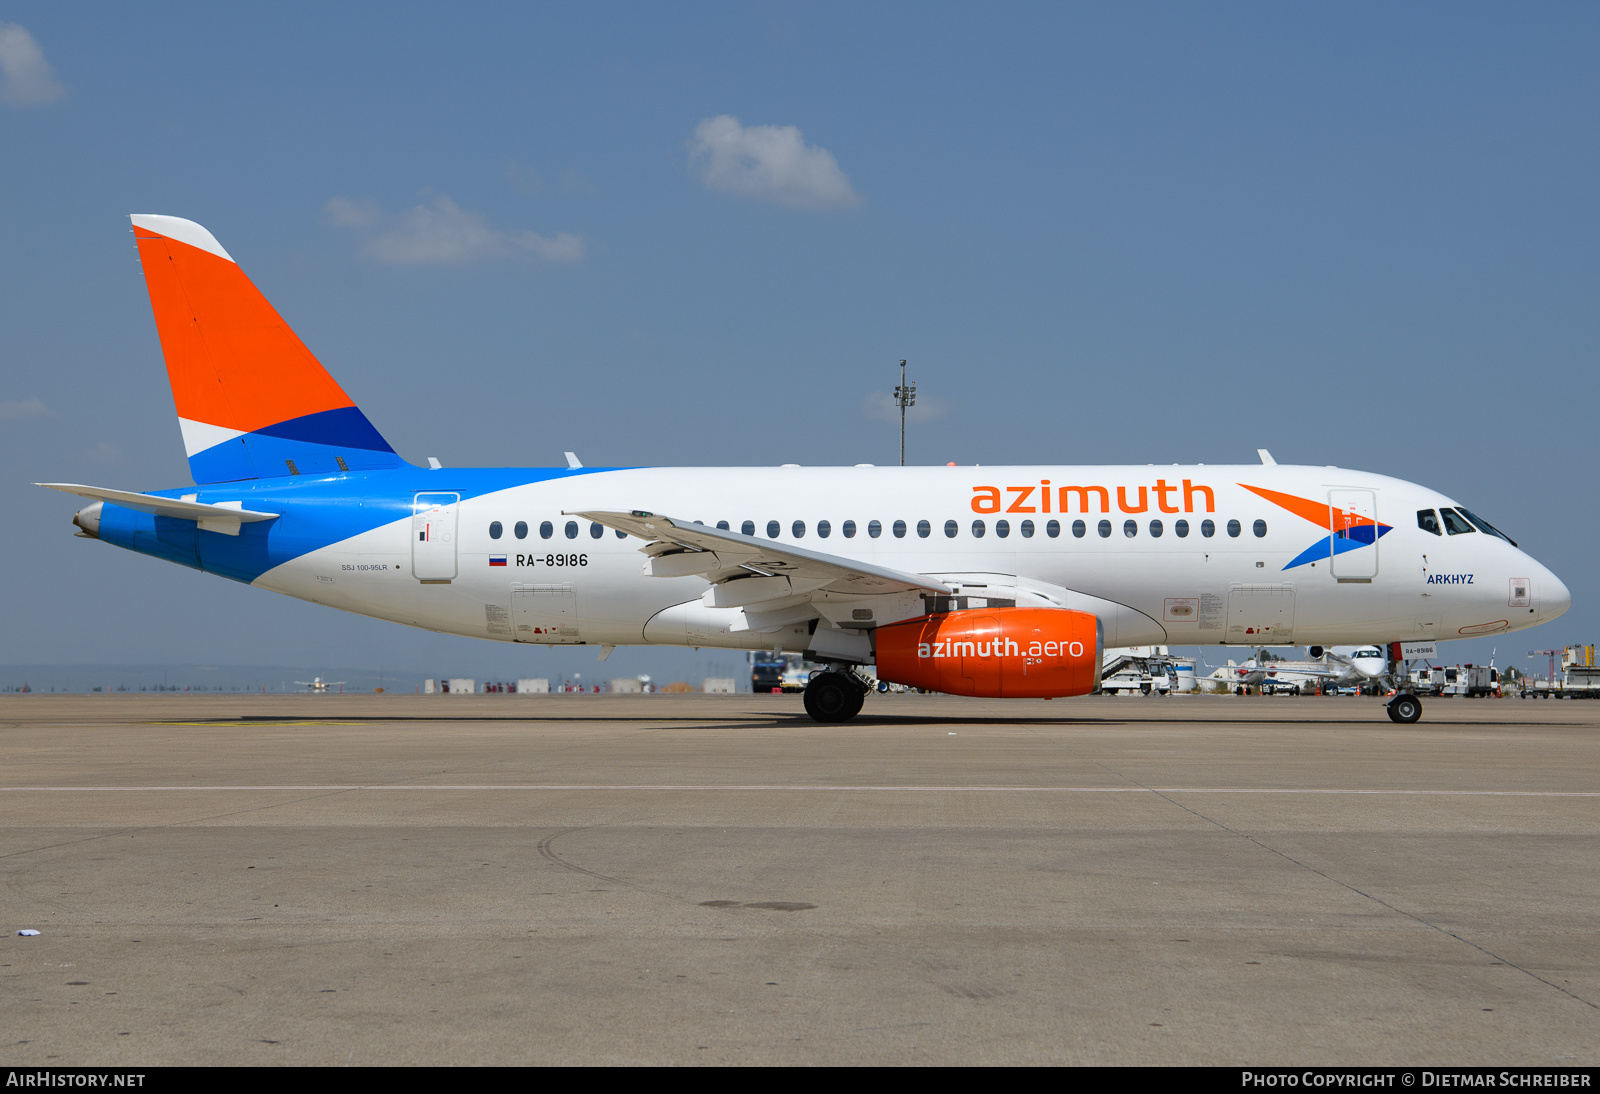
[131,214,400,483]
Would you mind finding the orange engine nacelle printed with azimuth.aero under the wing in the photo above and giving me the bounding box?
[877,608,1101,699]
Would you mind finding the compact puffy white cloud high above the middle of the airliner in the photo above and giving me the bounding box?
[688,114,861,210]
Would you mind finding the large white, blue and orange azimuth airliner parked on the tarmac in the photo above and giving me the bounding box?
[40,214,1571,723]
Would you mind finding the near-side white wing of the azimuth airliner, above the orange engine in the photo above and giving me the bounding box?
[563,510,950,600]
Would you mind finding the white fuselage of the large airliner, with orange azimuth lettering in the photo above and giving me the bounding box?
[254,465,1570,651]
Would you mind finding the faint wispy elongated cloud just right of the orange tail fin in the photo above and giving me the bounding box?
[323,194,584,266]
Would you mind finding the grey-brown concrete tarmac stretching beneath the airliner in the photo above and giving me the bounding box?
[0,696,1600,1067]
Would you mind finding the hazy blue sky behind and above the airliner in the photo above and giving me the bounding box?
[0,3,1600,677]
